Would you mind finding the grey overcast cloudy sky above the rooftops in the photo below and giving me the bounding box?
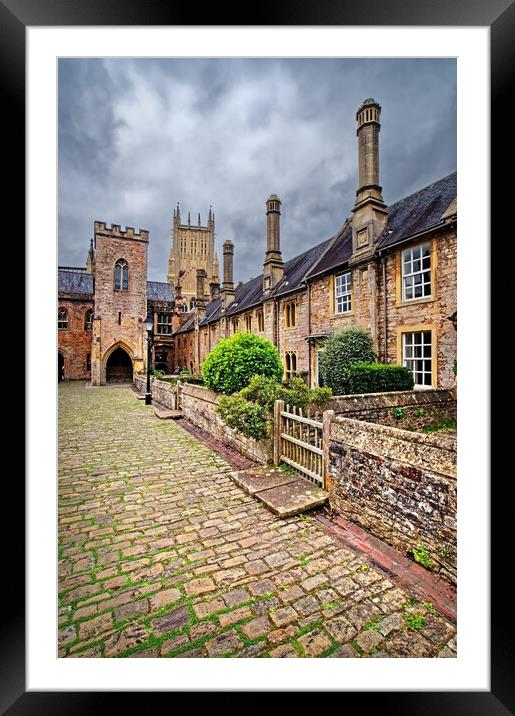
[59,59,456,282]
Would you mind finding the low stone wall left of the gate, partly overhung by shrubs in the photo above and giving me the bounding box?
[181,383,272,465]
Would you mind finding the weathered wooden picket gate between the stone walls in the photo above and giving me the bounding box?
[274,400,324,488]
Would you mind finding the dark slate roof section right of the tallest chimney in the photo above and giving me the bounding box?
[380,172,458,248]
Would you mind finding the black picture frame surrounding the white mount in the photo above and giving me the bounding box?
[7,0,515,716]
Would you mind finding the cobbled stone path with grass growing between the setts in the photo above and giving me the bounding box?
[59,383,456,658]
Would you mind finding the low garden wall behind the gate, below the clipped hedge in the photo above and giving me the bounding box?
[324,388,456,430]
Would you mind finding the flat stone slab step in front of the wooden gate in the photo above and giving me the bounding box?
[232,467,329,517]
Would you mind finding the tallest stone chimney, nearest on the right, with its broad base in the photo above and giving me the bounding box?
[351,98,388,263]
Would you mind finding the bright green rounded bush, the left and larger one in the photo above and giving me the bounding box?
[202,333,283,393]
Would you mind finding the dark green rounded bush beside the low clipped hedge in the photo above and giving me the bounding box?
[319,328,376,395]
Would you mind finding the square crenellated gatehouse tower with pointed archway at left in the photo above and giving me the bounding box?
[91,221,149,385]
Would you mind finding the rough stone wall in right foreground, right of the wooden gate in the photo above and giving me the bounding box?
[327,417,457,583]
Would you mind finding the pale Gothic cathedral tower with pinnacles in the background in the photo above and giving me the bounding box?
[167,205,219,308]
